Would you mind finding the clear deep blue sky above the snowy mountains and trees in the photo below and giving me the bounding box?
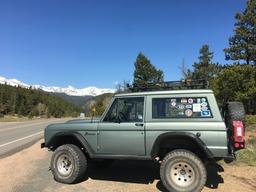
[0,0,246,88]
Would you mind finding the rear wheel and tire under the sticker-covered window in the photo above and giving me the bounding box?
[160,149,207,192]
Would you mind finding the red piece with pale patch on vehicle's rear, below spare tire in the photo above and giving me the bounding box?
[232,121,245,149]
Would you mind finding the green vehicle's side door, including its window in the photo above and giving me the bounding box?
[98,97,145,155]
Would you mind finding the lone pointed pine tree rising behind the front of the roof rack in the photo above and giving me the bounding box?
[133,53,164,87]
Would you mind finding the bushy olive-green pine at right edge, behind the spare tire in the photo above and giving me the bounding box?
[214,64,256,114]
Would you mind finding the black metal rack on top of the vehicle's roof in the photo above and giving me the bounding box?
[128,79,209,92]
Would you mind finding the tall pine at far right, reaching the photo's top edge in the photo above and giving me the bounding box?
[224,0,256,65]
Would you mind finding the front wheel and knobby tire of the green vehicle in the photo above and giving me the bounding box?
[50,144,87,184]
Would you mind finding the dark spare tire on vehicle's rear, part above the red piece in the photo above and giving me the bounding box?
[227,102,245,122]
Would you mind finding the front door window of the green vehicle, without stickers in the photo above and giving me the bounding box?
[103,97,144,122]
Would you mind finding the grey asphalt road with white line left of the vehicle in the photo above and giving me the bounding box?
[0,118,71,158]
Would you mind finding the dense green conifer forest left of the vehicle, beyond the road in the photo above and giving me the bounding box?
[0,85,81,118]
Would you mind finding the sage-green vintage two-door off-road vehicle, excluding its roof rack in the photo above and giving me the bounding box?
[42,81,245,191]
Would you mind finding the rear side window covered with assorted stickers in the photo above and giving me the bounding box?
[152,97,212,119]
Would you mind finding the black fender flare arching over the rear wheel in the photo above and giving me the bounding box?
[151,132,214,159]
